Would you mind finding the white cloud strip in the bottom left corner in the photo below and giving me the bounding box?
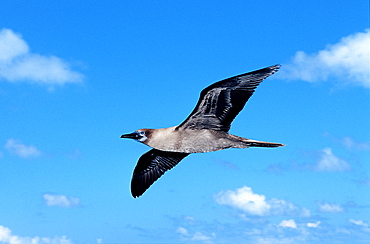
[0,225,72,244]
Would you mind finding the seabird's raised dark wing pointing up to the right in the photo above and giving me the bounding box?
[177,65,280,132]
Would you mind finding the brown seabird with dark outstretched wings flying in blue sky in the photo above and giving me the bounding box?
[121,65,284,198]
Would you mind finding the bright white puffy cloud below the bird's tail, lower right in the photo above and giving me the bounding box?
[215,186,310,216]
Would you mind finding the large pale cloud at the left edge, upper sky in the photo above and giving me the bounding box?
[0,29,83,86]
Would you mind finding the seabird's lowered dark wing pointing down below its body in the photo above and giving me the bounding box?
[131,149,189,197]
